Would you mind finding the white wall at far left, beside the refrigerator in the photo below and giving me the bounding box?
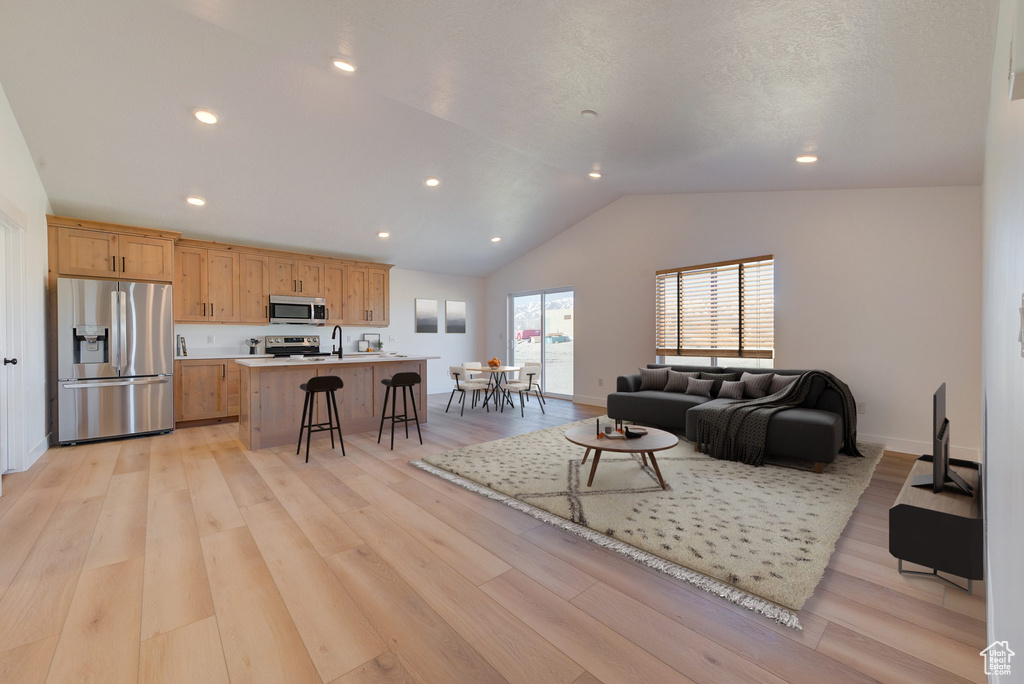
[0,86,49,470]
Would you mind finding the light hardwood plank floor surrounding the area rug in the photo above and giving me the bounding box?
[0,395,985,684]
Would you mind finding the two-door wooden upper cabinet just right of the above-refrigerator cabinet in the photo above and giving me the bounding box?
[174,246,241,323]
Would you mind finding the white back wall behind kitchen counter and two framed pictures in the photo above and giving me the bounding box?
[174,268,484,393]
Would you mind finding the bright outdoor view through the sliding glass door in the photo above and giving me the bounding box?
[509,289,573,398]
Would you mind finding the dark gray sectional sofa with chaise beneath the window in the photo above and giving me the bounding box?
[608,364,843,470]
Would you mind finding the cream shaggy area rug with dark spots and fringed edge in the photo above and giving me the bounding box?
[413,413,884,629]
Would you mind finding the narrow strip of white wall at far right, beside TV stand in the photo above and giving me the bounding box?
[982,0,1024,663]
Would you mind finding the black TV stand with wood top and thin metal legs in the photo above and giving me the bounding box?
[889,456,985,593]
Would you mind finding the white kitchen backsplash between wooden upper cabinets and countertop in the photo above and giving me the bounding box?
[174,324,402,356]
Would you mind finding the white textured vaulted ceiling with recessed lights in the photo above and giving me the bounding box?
[0,0,998,275]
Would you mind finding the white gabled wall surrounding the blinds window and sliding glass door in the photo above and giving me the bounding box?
[484,185,981,457]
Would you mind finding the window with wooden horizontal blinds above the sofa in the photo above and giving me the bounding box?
[654,255,775,358]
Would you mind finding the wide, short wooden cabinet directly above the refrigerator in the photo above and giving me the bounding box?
[48,216,180,283]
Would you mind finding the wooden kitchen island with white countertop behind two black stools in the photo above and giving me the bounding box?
[236,355,440,451]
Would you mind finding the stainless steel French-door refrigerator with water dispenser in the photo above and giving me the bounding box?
[57,277,174,444]
